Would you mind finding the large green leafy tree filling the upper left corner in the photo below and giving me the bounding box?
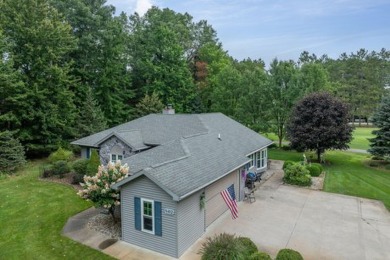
[0,0,76,154]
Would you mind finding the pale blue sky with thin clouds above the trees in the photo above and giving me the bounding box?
[107,0,390,64]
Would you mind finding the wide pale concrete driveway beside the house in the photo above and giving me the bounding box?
[180,162,390,260]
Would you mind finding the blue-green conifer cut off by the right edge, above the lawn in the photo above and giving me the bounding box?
[368,96,390,157]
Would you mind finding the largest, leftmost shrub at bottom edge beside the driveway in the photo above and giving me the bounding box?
[199,233,246,260]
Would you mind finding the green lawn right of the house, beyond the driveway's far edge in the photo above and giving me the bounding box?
[269,149,390,210]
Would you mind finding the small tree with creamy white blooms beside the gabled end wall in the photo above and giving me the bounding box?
[77,161,129,221]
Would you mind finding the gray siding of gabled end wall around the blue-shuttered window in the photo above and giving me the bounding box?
[121,176,177,257]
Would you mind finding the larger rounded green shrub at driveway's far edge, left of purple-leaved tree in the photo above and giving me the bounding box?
[283,163,311,186]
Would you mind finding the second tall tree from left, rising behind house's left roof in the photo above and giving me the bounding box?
[51,0,133,126]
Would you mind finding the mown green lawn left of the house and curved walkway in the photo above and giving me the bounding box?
[0,161,112,259]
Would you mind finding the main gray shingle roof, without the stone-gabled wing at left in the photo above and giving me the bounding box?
[106,113,272,200]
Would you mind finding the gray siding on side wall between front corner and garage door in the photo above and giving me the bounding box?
[177,191,205,256]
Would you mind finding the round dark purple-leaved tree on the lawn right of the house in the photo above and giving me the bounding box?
[287,92,352,161]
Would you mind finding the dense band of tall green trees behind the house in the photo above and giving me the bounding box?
[0,0,390,156]
